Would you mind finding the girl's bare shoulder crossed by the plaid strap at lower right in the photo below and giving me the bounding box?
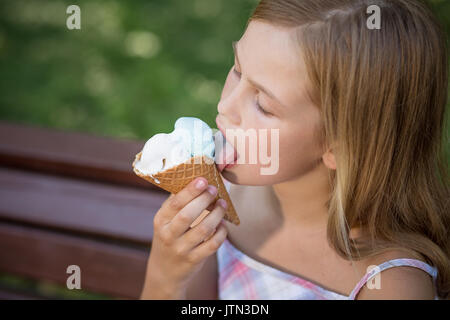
[356,251,435,300]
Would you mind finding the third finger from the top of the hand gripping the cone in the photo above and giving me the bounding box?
[181,199,226,250]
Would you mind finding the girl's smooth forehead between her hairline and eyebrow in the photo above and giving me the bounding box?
[237,21,306,108]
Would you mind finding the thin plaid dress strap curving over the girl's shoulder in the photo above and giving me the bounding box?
[349,259,437,300]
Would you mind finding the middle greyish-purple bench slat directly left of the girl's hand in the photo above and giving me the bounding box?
[0,168,167,245]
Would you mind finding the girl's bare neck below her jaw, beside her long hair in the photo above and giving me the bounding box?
[272,162,331,230]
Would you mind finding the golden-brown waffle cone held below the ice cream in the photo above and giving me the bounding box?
[133,152,240,225]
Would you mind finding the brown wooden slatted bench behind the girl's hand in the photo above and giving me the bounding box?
[0,122,168,299]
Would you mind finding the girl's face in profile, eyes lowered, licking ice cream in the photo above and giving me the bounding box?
[216,21,325,185]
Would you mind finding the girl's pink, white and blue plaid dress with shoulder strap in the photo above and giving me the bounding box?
[217,239,438,300]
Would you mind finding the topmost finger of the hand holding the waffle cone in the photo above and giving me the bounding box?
[159,177,208,225]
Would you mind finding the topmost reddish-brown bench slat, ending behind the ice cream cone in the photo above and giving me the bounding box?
[0,121,162,192]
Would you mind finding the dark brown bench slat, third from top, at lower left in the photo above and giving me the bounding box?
[0,223,149,299]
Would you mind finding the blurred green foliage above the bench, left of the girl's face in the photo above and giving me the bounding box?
[0,0,257,139]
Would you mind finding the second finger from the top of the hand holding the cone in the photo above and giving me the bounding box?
[167,186,217,238]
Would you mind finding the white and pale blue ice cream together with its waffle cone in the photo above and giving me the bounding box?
[133,118,239,225]
